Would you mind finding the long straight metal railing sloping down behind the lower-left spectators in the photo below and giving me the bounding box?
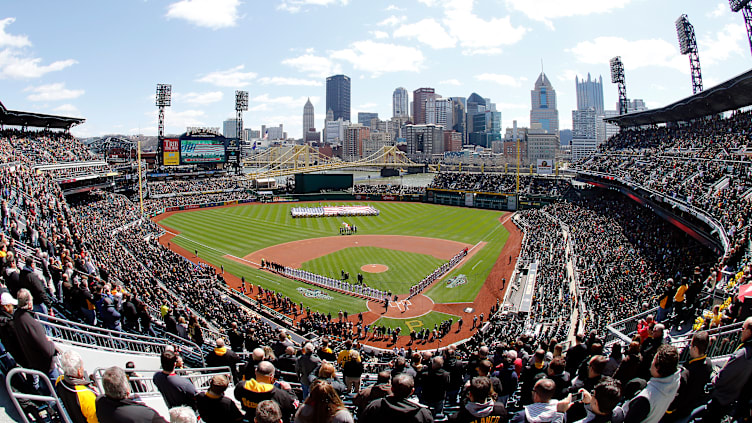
[36,313,205,367]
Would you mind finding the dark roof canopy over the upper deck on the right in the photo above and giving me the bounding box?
[605,70,752,127]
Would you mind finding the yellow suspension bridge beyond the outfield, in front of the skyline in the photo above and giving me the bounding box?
[243,145,425,179]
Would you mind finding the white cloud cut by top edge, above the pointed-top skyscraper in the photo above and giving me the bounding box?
[506,0,632,29]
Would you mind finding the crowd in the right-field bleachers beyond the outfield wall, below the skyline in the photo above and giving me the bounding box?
[428,172,571,197]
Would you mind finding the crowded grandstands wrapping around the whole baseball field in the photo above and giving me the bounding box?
[0,73,752,422]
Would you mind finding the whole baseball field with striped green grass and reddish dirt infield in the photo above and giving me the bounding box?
[155,202,509,340]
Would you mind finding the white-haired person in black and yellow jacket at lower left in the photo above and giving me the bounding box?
[54,350,98,423]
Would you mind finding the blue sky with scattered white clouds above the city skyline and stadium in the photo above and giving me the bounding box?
[0,0,752,138]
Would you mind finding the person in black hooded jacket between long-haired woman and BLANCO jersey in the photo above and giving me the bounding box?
[363,373,433,423]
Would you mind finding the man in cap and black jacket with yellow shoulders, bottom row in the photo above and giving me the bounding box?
[235,361,298,423]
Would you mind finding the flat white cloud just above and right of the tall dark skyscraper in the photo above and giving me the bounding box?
[331,40,425,77]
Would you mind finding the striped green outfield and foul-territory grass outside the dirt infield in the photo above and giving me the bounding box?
[161,202,509,320]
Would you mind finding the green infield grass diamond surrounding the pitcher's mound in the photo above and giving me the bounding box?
[303,247,444,296]
